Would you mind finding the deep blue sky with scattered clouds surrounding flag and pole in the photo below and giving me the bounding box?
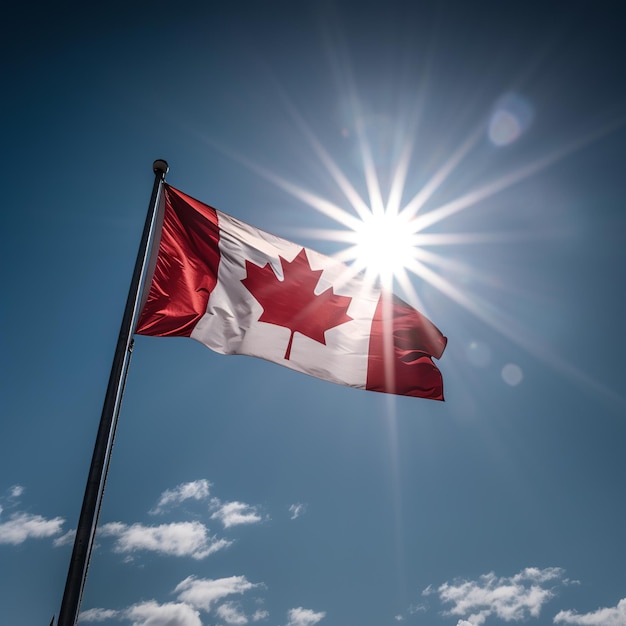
[0,0,626,626]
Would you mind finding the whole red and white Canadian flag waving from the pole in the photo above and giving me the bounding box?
[136,184,447,400]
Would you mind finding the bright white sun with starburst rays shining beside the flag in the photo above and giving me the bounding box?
[201,75,626,405]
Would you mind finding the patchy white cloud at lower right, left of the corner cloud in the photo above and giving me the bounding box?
[434,567,563,626]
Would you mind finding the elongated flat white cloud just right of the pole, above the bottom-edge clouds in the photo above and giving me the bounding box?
[100,522,232,559]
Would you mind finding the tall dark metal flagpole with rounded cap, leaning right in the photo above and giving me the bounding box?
[57,159,169,626]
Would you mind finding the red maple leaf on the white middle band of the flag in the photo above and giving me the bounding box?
[241,248,352,359]
